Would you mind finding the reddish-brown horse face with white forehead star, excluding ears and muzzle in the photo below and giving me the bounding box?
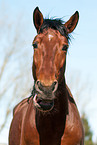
[33,29,68,87]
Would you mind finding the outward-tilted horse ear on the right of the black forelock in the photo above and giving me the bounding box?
[64,11,79,33]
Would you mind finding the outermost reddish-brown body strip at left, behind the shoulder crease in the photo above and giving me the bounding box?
[9,99,28,145]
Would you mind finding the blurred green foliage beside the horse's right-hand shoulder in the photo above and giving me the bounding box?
[82,114,97,145]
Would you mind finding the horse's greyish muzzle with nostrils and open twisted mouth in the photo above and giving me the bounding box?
[33,81,58,112]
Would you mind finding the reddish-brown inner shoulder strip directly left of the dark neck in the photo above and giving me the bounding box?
[21,100,39,145]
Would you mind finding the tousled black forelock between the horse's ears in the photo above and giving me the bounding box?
[39,19,70,40]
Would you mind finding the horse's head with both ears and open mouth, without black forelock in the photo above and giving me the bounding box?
[33,8,78,111]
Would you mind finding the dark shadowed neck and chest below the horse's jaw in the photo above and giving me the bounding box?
[35,76,68,145]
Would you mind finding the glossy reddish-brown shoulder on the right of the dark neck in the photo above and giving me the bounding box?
[61,86,84,145]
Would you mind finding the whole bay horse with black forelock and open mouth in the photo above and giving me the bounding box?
[9,7,84,145]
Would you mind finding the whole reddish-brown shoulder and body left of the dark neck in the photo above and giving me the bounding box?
[9,98,39,145]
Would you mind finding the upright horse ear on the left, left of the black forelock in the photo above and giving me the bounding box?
[33,7,43,32]
